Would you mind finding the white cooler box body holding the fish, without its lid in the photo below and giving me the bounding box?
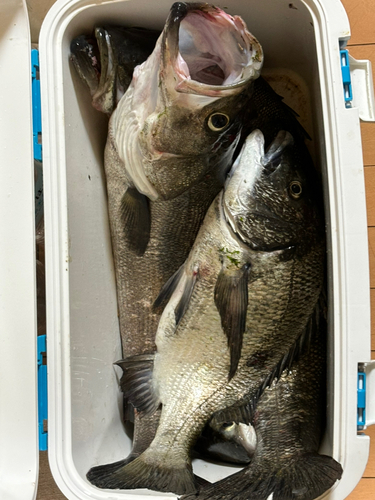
[40,0,370,500]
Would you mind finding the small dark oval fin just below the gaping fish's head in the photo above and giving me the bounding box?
[120,188,151,256]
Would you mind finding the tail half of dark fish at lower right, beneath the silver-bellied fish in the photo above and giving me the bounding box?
[181,300,342,500]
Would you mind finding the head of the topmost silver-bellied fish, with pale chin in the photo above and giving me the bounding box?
[223,130,324,251]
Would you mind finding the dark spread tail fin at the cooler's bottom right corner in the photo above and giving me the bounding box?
[180,453,342,500]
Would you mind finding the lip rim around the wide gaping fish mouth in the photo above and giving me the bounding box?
[161,2,263,97]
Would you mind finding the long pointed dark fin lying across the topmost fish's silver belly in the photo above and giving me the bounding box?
[214,264,250,380]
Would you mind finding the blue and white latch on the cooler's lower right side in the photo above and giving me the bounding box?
[357,360,375,431]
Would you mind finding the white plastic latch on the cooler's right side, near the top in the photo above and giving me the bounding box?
[349,55,375,122]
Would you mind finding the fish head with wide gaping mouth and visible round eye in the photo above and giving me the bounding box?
[127,2,263,199]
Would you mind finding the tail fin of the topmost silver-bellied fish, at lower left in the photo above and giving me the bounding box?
[87,454,197,495]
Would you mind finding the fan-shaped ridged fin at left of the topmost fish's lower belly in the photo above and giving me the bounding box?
[115,354,160,414]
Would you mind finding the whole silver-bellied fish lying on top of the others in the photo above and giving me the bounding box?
[89,130,325,494]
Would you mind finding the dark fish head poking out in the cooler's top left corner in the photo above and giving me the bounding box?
[70,26,160,115]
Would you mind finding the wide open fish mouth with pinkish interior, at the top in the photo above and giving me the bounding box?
[162,2,263,95]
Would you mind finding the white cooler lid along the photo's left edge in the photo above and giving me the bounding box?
[0,0,38,500]
